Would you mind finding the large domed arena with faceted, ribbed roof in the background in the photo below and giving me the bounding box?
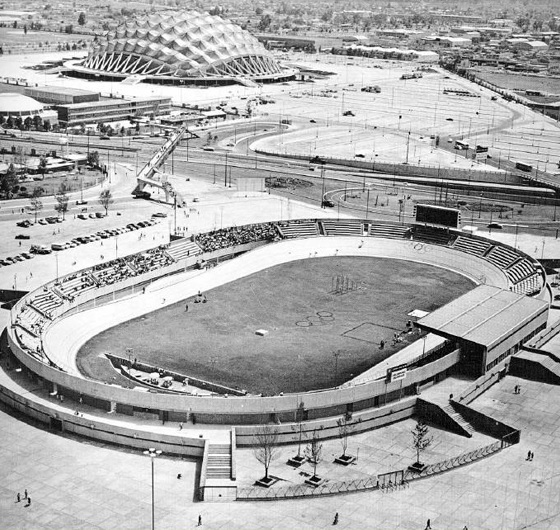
[72,11,295,85]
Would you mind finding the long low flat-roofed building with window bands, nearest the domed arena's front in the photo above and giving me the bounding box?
[56,98,171,127]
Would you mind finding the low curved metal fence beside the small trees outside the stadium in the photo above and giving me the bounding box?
[237,433,518,501]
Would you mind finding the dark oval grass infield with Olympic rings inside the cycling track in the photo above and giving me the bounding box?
[78,257,473,394]
